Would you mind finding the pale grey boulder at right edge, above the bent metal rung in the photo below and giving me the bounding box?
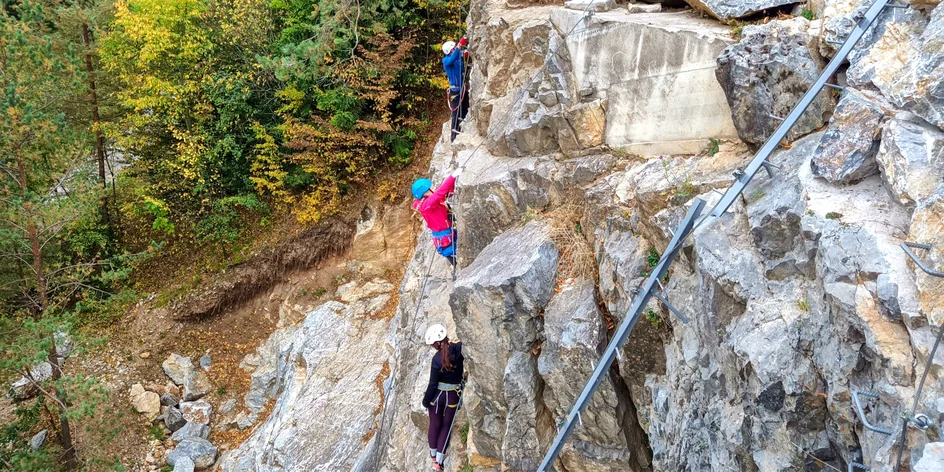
[876,118,944,206]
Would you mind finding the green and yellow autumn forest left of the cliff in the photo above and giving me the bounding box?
[0,0,465,471]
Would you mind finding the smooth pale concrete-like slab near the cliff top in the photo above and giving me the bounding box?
[551,9,737,155]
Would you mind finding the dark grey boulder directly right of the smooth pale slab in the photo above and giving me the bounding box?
[715,18,836,145]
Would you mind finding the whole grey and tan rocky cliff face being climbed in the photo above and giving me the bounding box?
[223,0,944,471]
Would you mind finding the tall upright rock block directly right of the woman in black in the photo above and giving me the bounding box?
[449,222,560,470]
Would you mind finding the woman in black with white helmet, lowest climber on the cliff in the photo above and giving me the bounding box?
[423,324,463,470]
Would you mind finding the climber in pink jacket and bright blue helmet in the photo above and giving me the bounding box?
[411,167,462,267]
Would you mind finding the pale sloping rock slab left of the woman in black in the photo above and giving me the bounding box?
[220,279,393,471]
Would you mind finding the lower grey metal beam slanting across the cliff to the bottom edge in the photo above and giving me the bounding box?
[538,198,705,472]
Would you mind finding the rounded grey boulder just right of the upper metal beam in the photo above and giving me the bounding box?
[810,88,885,183]
